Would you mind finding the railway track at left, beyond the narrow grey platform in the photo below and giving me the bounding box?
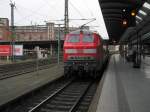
[0,59,61,80]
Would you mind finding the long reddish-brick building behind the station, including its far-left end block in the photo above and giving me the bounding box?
[0,18,78,41]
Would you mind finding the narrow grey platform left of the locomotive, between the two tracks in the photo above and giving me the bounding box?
[0,64,63,105]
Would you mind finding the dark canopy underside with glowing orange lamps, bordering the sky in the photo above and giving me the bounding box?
[99,0,145,42]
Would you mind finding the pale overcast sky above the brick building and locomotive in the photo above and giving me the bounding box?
[0,0,108,38]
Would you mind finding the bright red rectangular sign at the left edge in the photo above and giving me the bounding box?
[0,45,12,56]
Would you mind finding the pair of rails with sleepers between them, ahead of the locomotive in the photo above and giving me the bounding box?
[28,79,92,112]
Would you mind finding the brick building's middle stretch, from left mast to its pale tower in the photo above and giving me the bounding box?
[15,23,55,41]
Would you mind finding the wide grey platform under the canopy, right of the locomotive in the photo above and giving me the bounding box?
[95,54,150,112]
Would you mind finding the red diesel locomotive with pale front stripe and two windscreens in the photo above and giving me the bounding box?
[63,30,105,77]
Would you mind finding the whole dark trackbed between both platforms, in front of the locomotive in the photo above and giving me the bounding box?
[0,79,98,112]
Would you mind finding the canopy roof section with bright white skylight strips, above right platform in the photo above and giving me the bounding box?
[120,0,150,44]
